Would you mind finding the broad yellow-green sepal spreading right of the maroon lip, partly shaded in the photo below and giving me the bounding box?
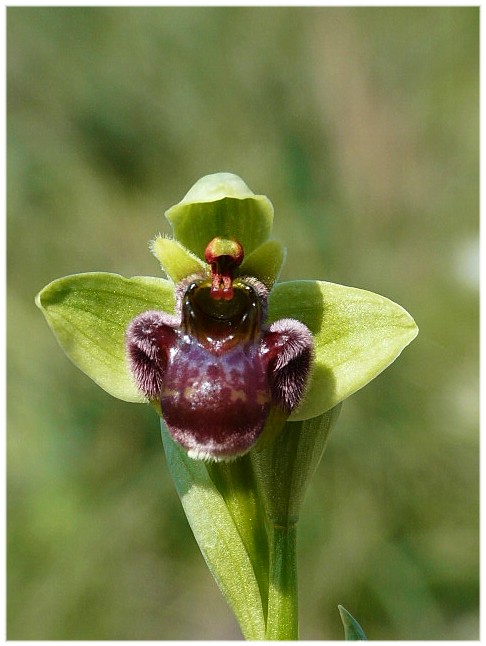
[269,280,418,421]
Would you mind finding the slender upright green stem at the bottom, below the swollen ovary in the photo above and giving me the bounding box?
[265,524,299,640]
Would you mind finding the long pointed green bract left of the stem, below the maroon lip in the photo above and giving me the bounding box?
[161,421,265,640]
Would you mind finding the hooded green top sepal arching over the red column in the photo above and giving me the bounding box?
[165,173,273,258]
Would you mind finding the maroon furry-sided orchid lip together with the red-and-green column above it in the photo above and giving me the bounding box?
[127,238,312,460]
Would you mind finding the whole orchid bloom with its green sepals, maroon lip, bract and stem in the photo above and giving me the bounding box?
[36,173,417,639]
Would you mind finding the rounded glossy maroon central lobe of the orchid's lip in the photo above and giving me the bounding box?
[161,339,271,457]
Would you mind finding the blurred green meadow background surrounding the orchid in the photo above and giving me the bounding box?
[7,7,479,640]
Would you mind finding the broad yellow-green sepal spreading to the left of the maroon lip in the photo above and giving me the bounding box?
[36,272,174,402]
